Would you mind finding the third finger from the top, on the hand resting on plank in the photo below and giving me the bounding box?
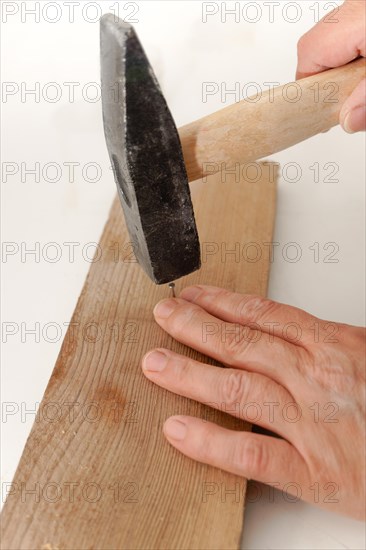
[142,348,293,437]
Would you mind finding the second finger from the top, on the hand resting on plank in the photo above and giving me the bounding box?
[154,298,301,387]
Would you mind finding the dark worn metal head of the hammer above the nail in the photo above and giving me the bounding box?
[101,14,200,284]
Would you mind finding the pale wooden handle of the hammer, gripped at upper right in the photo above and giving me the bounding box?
[179,59,365,181]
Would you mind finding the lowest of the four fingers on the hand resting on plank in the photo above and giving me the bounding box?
[164,416,308,494]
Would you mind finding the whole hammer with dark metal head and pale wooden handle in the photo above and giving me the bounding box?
[100,14,365,284]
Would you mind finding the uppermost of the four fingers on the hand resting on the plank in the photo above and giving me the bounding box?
[180,285,328,346]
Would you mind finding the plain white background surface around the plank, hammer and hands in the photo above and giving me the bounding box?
[1,0,365,549]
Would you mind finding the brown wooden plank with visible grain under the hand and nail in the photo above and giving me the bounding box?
[2,163,276,550]
